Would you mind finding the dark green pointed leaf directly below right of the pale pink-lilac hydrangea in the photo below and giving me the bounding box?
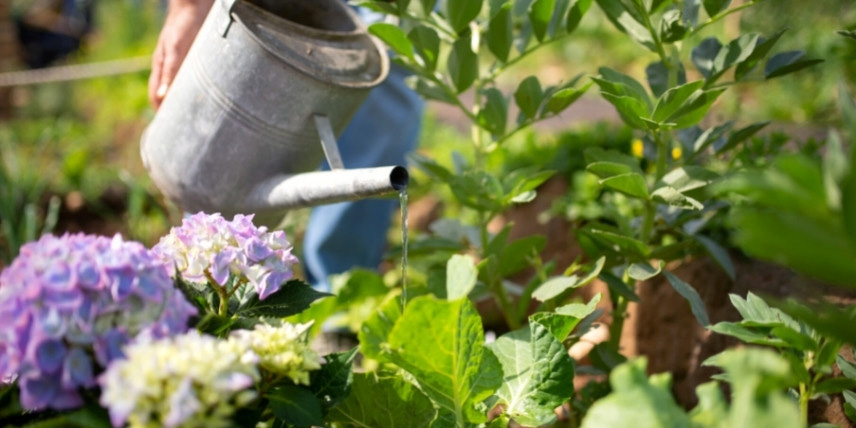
[235,280,330,318]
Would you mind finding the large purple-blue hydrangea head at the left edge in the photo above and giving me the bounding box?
[0,234,196,410]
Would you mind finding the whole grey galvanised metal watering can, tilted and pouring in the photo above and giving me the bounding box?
[140,0,409,219]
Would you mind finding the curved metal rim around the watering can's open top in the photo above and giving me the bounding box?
[219,0,390,89]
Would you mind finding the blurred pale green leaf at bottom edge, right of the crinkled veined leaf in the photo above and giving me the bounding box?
[581,357,691,428]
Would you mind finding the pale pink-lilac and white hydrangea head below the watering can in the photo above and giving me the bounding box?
[153,213,298,299]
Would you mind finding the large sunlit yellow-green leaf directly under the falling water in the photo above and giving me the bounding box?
[388,296,502,427]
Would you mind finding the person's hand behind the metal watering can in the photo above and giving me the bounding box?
[149,0,214,109]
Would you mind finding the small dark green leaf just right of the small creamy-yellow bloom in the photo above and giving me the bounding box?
[309,348,358,413]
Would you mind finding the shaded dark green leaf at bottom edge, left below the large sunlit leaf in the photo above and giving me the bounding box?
[326,373,437,428]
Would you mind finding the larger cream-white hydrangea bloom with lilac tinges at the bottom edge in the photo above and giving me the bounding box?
[99,331,259,427]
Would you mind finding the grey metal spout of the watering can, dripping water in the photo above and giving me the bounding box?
[245,166,410,212]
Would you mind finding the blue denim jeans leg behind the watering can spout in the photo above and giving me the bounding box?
[303,66,423,291]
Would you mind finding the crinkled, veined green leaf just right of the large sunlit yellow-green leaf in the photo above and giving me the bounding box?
[488,323,574,426]
